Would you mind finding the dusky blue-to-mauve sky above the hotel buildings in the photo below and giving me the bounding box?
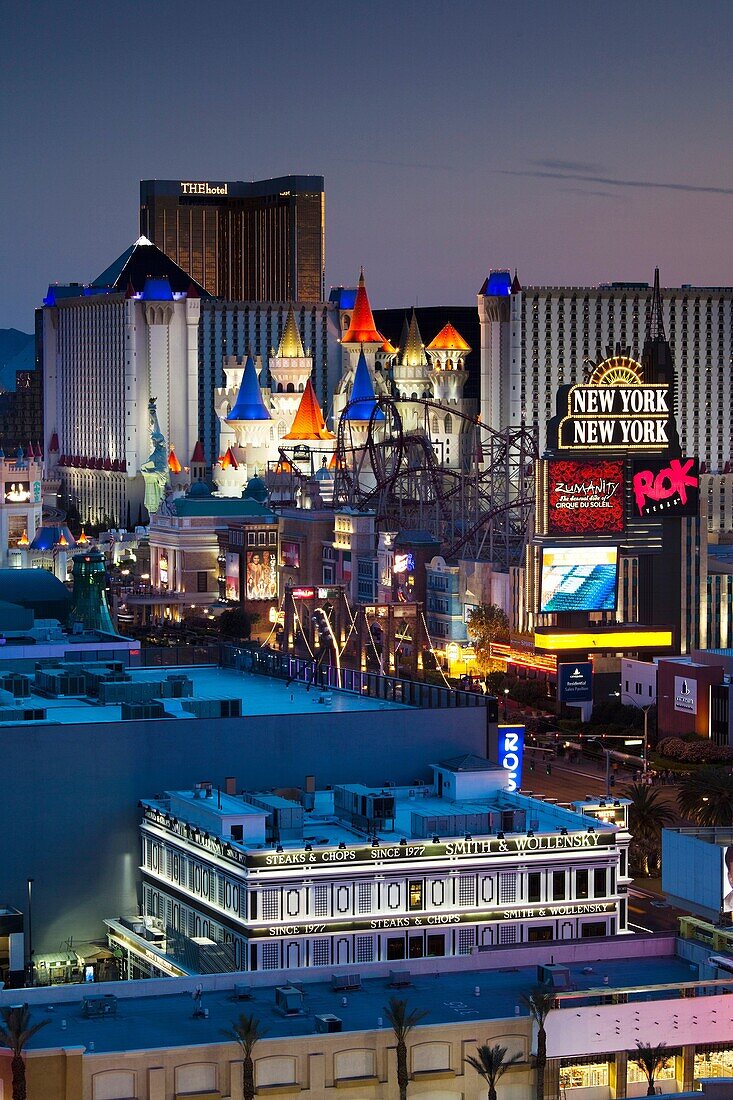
[0,0,733,331]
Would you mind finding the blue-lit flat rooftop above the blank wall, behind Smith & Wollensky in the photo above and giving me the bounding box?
[0,666,413,727]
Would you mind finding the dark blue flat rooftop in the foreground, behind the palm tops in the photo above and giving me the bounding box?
[15,944,699,1053]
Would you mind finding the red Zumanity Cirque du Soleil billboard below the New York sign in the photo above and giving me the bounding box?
[547,459,624,536]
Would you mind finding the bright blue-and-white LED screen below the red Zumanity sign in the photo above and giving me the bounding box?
[539,546,619,612]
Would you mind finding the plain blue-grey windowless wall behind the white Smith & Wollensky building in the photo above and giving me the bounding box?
[5,704,486,950]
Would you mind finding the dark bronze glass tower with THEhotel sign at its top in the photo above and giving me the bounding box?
[140,176,325,301]
